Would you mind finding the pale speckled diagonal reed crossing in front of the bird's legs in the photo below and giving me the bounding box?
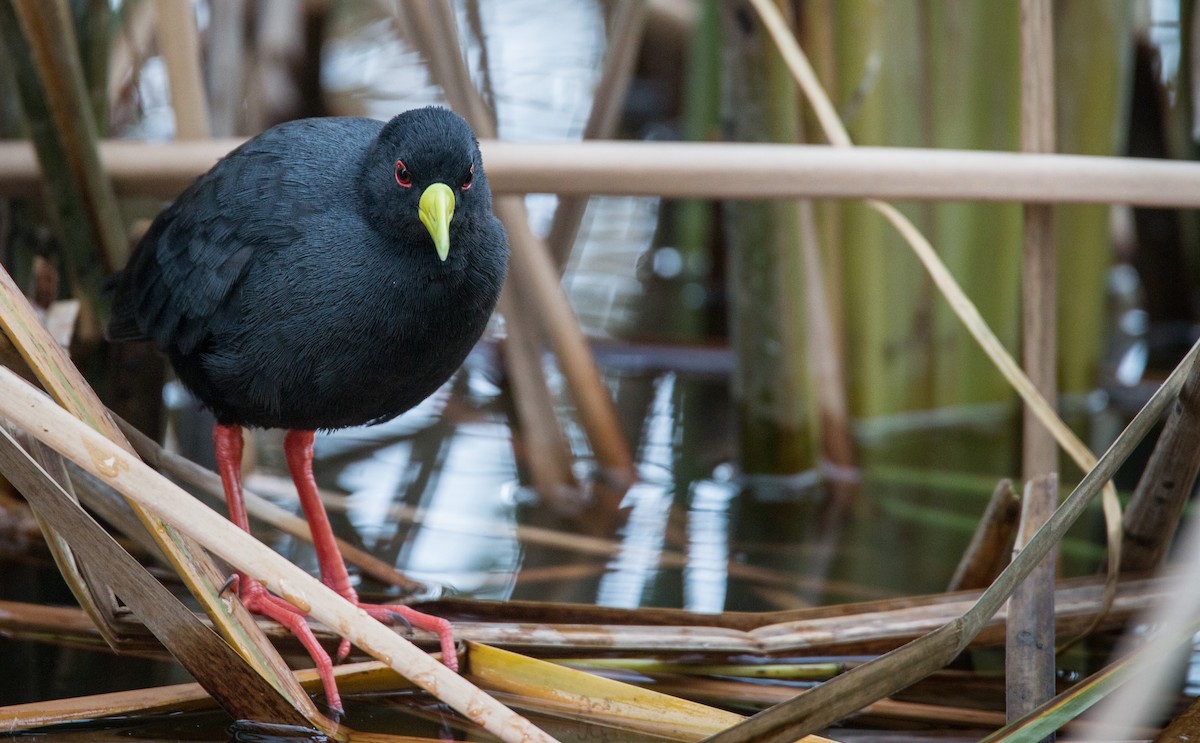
[0,368,553,743]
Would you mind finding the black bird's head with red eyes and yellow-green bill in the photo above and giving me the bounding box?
[364,106,491,260]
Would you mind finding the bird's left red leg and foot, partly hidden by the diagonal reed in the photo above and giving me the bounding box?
[212,424,342,713]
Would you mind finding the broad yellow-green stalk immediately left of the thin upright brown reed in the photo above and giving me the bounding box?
[926,0,1021,410]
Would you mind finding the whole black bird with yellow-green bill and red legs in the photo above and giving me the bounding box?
[107,107,509,709]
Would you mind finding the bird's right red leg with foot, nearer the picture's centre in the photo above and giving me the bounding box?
[283,431,458,671]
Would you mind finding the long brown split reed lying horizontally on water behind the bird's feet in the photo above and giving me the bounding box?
[0,577,1170,670]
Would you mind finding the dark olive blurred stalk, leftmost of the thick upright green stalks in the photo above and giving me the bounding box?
[722,0,816,474]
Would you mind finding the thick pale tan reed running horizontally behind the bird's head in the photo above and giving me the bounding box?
[7,138,1200,209]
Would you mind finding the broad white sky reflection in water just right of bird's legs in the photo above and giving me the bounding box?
[323,368,520,598]
